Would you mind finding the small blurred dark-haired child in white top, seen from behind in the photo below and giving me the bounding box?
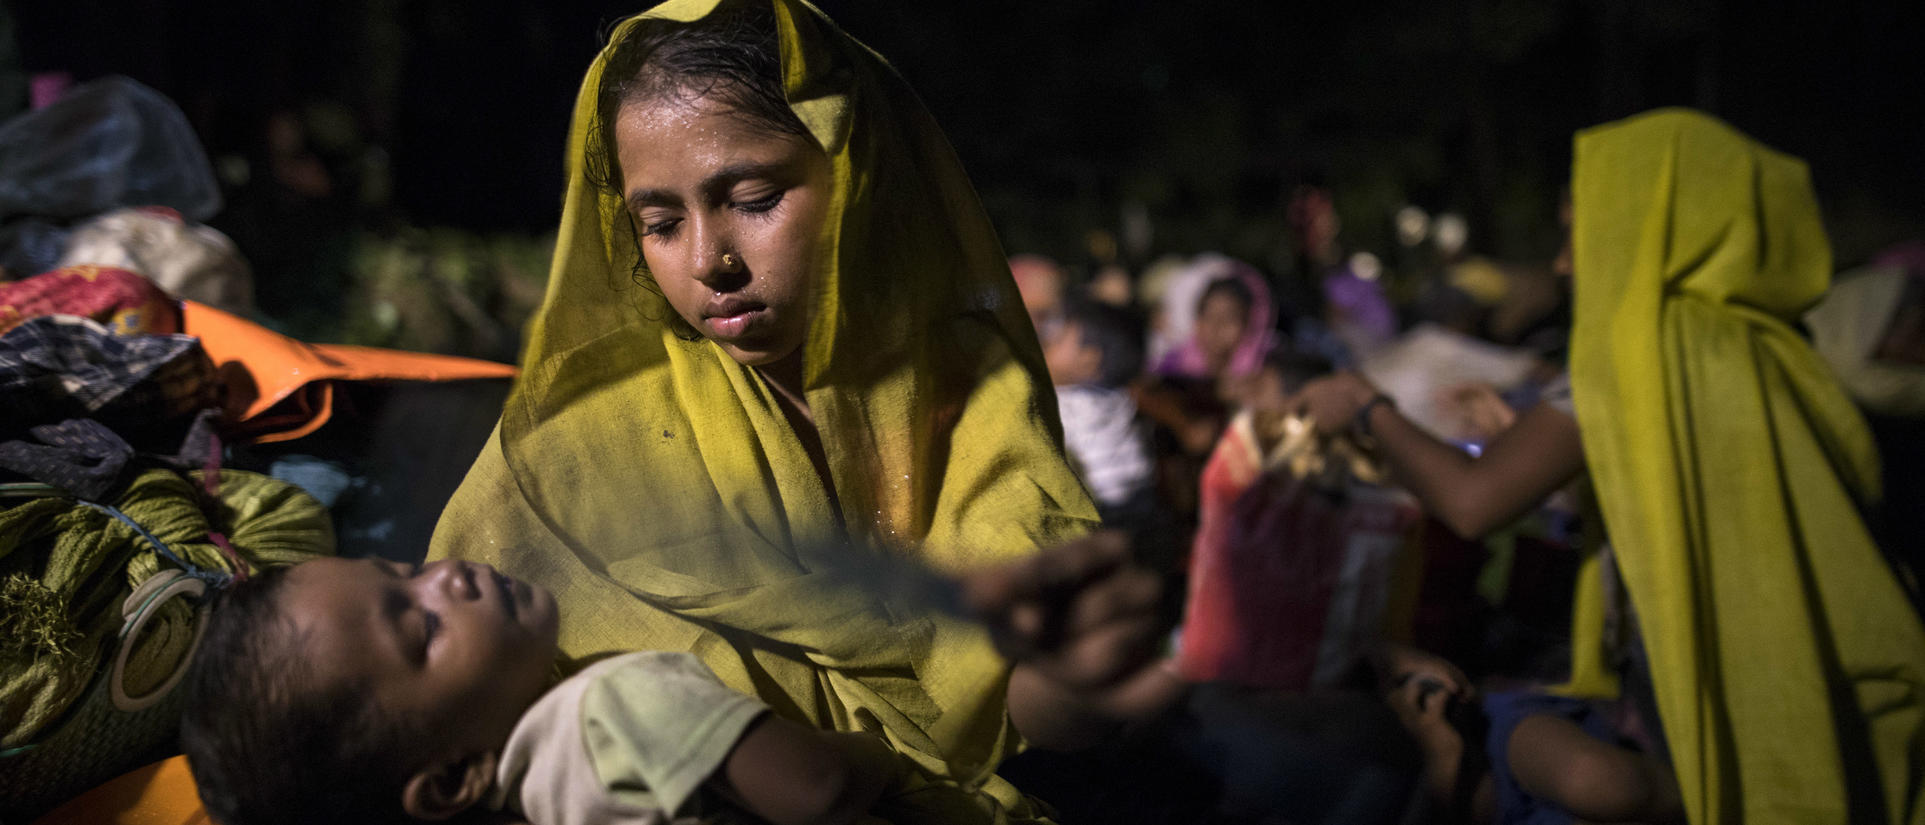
[1043,302,1155,523]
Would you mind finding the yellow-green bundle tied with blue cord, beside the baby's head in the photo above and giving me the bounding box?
[0,469,335,815]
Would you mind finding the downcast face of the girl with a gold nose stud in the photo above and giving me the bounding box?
[614,96,832,367]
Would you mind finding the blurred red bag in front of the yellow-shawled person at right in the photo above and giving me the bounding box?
[1176,415,1421,690]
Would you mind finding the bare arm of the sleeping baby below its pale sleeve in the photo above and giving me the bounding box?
[708,713,901,825]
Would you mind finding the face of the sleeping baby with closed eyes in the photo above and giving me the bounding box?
[281,558,556,756]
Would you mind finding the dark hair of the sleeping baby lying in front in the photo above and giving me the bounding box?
[181,567,425,825]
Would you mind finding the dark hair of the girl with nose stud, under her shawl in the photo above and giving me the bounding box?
[583,0,809,332]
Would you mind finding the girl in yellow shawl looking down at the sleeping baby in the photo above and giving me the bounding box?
[429,0,1165,821]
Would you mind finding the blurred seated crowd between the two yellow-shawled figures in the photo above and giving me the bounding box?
[1011,187,1571,542]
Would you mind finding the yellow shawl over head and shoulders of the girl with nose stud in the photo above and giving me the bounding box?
[431,0,1095,821]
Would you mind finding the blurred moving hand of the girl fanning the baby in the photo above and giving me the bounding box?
[963,531,1163,698]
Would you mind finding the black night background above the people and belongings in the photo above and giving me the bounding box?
[8,0,1925,344]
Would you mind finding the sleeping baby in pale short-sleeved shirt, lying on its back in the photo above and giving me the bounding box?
[181,558,899,825]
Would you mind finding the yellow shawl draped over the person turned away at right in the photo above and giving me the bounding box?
[1571,110,1925,823]
